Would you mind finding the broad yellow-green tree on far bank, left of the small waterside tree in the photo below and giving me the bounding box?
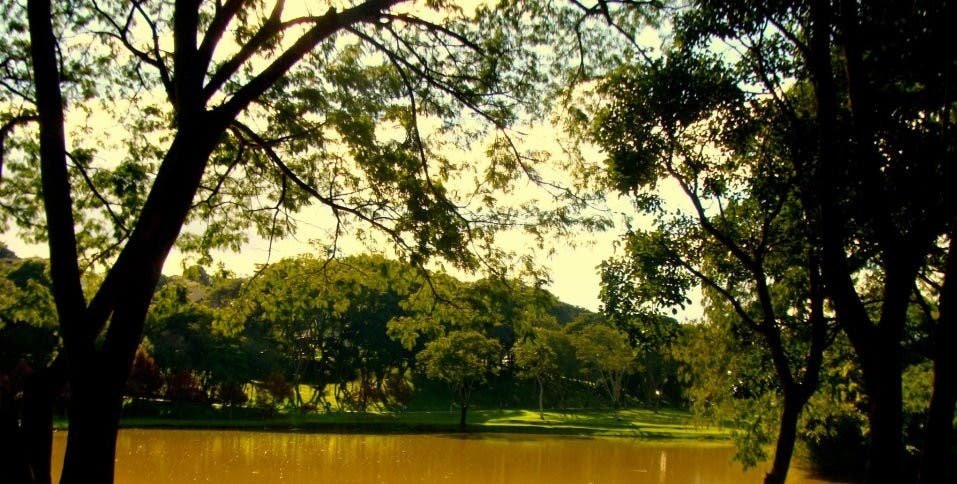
[230,256,427,411]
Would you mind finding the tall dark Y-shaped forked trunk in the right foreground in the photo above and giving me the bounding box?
[806,0,919,483]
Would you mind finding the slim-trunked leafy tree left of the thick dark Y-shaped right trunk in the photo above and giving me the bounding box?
[591,41,828,482]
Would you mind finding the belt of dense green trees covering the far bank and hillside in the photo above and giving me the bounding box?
[0,250,684,425]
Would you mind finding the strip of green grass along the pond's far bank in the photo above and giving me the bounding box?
[78,409,730,441]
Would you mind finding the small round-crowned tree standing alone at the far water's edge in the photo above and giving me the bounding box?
[416,330,502,428]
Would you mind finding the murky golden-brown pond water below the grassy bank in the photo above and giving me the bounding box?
[48,430,821,484]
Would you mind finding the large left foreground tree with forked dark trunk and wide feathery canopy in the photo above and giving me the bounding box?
[2,0,560,482]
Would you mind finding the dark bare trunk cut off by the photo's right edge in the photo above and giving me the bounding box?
[918,220,957,484]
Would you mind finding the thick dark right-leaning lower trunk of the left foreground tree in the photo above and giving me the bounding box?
[55,122,225,483]
